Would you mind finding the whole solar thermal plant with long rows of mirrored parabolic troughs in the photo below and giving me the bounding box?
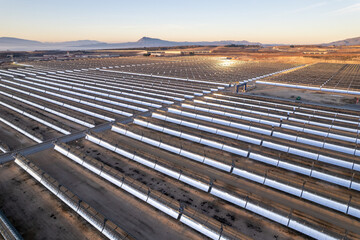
[0,56,360,240]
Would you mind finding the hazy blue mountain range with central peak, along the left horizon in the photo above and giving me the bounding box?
[0,37,261,51]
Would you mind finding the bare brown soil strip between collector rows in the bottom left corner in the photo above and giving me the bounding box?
[0,162,106,240]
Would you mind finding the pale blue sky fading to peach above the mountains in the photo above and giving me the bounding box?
[0,0,360,44]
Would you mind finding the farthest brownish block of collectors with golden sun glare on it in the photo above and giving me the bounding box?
[26,57,293,82]
